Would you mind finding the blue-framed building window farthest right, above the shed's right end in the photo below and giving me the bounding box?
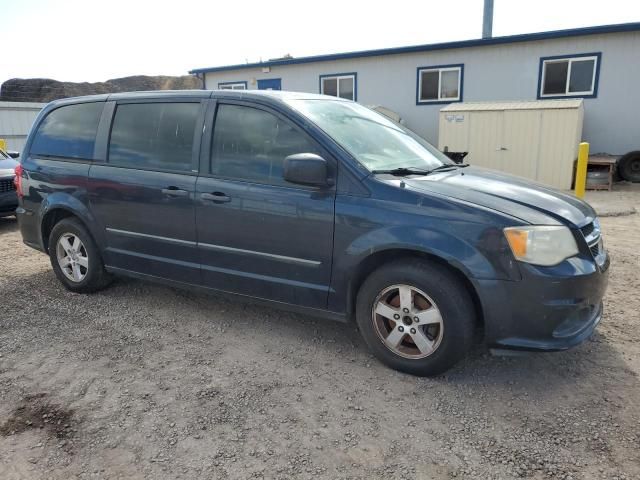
[538,53,600,98]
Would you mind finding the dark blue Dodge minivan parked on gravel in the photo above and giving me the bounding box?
[16,91,609,375]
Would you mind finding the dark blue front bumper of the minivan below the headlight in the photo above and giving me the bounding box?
[476,255,609,351]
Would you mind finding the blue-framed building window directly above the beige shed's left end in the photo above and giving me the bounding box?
[417,65,464,104]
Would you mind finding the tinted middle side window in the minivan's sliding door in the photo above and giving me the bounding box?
[109,103,200,171]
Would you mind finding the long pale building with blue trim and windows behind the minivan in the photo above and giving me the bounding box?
[190,23,640,177]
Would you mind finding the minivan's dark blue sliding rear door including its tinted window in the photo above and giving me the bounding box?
[87,99,204,283]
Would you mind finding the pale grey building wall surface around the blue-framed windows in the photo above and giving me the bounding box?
[205,32,640,154]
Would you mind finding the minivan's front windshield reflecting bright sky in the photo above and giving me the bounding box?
[288,99,455,172]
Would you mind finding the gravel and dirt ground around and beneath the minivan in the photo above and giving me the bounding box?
[0,189,640,480]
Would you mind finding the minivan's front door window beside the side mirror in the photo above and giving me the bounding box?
[210,105,318,186]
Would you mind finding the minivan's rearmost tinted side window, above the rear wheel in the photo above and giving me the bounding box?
[31,102,104,159]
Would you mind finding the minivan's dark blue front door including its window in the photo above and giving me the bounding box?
[196,102,335,308]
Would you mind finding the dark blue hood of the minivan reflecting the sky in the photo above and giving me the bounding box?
[404,167,596,227]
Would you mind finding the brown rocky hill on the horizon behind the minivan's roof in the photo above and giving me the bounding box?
[0,75,202,102]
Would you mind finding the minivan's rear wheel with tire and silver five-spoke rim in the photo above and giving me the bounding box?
[49,218,111,293]
